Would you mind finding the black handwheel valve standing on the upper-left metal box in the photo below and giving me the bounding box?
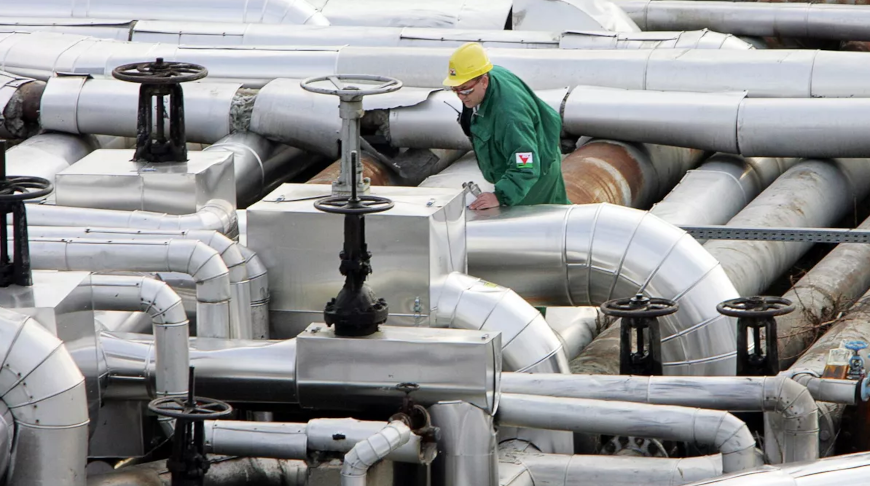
[112,57,208,162]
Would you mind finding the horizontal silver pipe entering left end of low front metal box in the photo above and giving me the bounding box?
[100,333,298,404]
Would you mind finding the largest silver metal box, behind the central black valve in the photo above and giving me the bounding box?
[246,184,467,339]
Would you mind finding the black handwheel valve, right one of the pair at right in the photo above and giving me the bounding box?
[716,296,794,376]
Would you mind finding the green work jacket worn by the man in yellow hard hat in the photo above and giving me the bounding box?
[470,66,571,206]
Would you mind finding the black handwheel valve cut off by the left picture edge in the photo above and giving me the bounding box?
[0,140,53,287]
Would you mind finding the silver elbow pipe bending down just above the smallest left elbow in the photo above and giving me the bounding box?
[30,238,231,338]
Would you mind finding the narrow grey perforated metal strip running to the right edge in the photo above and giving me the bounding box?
[680,226,870,243]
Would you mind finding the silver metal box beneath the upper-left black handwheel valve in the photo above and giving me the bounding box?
[54,150,236,214]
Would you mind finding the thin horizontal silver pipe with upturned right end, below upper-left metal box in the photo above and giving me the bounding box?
[23,197,238,238]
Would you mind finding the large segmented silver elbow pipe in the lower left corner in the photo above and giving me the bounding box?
[0,309,88,486]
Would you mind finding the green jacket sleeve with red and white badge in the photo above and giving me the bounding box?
[494,108,541,206]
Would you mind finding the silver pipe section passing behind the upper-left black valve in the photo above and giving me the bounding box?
[40,75,241,143]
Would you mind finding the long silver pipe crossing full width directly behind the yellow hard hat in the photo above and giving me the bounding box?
[0,32,870,94]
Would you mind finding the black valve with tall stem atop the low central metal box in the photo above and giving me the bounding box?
[314,152,393,336]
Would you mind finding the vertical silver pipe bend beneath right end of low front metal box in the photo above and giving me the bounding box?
[429,402,501,486]
